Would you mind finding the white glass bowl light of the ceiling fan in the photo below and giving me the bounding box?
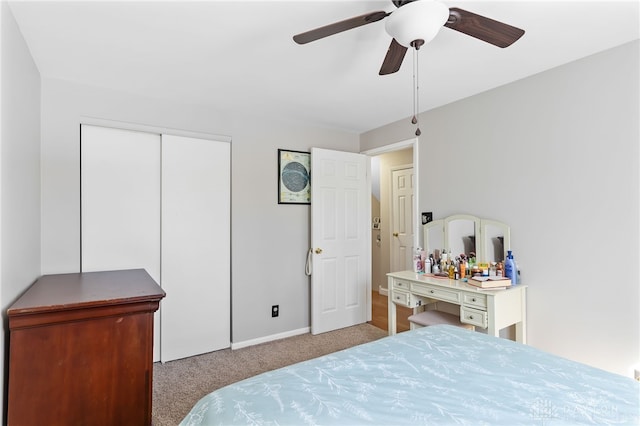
[385,0,449,47]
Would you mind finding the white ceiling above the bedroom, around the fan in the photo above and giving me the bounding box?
[9,0,640,133]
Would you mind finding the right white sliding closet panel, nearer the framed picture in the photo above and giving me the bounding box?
[161,135,231,362]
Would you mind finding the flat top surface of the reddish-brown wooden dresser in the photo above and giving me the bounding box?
[7,269,165,317]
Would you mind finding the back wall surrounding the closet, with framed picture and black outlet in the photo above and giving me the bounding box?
[42,79,358,343]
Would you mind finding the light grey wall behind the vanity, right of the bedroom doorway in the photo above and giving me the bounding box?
[361,41,640,375]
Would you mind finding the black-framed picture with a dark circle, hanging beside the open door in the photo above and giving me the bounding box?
[278,149,311,204]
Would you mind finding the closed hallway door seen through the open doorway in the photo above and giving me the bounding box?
[391,167,414,272]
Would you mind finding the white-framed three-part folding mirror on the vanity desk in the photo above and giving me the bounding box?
[423,214,511,262]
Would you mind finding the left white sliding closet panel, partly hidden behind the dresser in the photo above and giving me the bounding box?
[80,125,164,360]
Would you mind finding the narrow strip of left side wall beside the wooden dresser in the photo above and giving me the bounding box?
[0,2,40,417]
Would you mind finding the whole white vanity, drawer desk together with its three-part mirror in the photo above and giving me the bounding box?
[387,214,527,343]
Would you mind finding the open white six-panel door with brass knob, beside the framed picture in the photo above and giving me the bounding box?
[311,148,371,334]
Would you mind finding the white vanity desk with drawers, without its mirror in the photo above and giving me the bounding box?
[387,271,527,343]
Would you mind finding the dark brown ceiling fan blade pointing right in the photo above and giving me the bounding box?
[444,7,524,47]
